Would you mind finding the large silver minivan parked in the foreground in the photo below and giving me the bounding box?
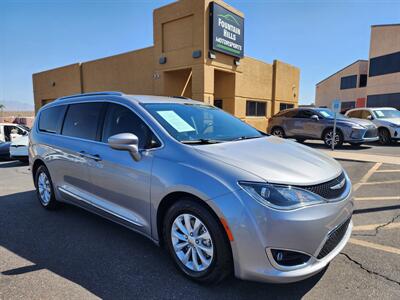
[29,92,353,283]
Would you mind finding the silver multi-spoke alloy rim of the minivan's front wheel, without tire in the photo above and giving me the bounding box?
[171,214,214,272]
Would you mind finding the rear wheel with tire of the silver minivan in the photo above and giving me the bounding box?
[35,165,59,210]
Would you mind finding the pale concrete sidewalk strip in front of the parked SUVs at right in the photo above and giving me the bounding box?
[320,148,400,165]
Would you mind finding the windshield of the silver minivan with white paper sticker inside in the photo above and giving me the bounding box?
[143,103,265,144]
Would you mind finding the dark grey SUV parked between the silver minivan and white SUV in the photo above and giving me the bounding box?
[267,108,378,147]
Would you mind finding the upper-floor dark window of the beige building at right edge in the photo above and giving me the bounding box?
[369,52,400,77]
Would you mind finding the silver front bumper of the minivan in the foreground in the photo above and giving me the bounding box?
[210,182,353,283]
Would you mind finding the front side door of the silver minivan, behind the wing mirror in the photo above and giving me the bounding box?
[90,103,158,234]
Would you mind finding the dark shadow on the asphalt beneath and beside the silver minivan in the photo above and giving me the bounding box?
[0,191,324,299]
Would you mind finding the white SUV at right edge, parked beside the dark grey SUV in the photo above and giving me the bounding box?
[346,107,400,145]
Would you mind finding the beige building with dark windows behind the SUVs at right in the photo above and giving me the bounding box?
[315,24,400,110]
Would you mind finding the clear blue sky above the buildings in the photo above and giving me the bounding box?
[0,0,400,107]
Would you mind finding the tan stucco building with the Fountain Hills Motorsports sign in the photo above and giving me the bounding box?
[33,0,300,130]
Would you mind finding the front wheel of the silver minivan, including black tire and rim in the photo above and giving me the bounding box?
[163,198,232,284]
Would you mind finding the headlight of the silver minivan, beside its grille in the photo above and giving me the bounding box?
[239,181,326,210]
